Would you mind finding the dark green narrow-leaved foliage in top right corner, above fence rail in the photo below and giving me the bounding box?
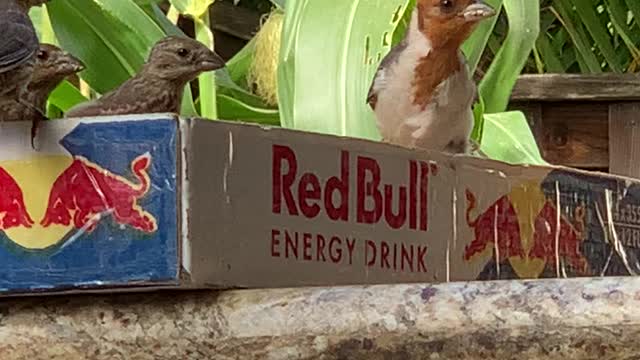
[480,0,640,74]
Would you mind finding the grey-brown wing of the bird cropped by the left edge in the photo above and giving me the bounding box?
[0,8,39,73]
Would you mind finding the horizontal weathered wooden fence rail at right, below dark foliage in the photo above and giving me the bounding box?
[511,73,640,101]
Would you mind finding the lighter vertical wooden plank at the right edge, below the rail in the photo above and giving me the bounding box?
[609,102,640,178]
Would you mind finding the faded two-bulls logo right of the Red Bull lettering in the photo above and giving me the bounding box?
[463,182,587,278]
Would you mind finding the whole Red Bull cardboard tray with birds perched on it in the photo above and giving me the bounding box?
[0,114,640,295]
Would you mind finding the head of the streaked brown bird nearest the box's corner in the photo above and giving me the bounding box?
[144,36,225,83]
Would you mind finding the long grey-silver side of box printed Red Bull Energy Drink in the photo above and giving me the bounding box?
[182,120,640,287]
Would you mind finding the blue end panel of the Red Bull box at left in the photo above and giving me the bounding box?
[0,116,180,293]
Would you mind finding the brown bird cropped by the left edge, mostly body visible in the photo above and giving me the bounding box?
[0,0,47,102]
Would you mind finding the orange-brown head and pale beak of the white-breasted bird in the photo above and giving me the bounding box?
[416,0,496,48]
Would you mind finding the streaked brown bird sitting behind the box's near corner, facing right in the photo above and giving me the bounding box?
[65,36,225,117]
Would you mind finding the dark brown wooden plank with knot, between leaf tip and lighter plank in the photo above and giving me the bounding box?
[510,102,609,170]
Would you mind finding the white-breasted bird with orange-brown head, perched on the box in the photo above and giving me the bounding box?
[367,0,496,154]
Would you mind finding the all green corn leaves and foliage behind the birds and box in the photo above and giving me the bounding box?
[31,0,640,164]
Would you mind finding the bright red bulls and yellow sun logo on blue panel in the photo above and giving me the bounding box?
[0,153,158,249]
